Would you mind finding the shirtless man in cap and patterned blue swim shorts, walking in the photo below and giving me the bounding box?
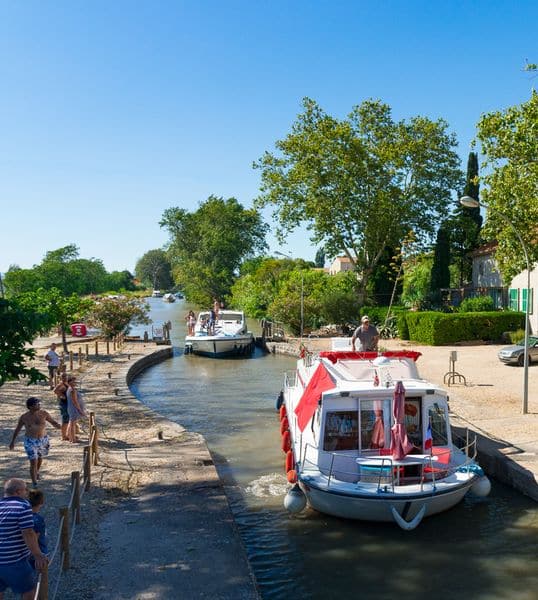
[9,397,62,486]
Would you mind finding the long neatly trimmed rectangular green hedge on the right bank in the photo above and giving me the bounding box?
[398,311,525,346]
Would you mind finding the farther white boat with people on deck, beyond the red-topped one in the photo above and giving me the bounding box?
[185,309,254,357]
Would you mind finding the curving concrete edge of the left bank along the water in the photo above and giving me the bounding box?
[116,346,261,600]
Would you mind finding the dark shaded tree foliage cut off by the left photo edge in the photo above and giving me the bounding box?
[0,298,49,386]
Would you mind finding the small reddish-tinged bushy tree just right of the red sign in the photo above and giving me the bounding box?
[89,298,151,339]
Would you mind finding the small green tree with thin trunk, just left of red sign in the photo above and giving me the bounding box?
[18,288,93,352]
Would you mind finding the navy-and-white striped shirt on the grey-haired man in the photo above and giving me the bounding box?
[0,496,34,565]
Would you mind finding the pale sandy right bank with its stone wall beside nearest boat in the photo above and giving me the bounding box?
[265,338,538,501]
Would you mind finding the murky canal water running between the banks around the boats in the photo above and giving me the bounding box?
[131,299,538,600]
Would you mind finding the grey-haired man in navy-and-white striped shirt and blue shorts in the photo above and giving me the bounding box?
[0,478,47,600]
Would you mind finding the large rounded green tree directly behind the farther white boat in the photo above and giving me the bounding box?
[160,196,267,306]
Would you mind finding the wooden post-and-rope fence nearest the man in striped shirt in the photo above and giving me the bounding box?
[34,412,99,600]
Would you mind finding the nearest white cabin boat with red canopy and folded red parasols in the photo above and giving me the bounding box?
[277,351,491,530]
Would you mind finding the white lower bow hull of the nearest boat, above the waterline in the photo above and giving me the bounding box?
[299,478,474,522]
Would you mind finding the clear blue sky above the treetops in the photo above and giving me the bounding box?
[0,0,538,271]
